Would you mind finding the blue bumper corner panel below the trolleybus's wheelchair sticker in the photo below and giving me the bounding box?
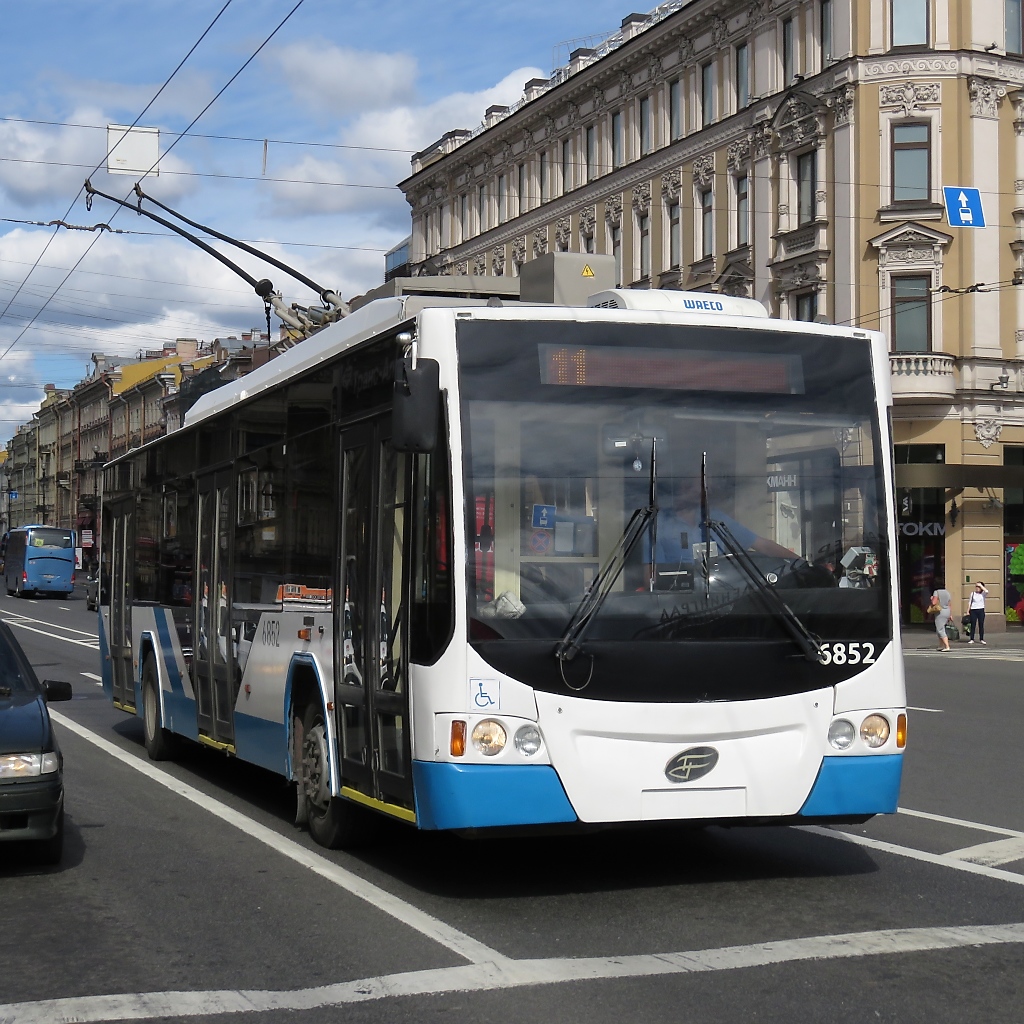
[413,761,577,828]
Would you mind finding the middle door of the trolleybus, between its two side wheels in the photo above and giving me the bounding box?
[193,471,236,749]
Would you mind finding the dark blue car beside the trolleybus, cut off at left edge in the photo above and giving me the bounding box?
[0,623,72,864]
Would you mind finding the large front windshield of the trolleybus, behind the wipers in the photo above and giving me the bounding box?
[458,322,891,650]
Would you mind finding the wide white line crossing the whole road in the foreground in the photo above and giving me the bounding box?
[0,924,1024,1024]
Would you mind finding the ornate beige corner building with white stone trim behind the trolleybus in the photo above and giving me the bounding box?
[401,0,1024,629]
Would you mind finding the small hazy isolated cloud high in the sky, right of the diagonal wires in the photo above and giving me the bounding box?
[270,43,417,117]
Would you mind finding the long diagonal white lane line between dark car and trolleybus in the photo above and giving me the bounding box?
[48,710,506,966]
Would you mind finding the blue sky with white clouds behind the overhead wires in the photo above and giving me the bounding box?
[0,0,626,443]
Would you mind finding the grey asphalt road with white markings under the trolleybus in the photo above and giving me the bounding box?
[0,594,1024,1024]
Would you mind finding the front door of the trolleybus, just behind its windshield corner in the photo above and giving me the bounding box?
[335,420,413,809]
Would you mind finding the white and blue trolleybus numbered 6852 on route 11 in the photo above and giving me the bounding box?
[100,291,906,846]
